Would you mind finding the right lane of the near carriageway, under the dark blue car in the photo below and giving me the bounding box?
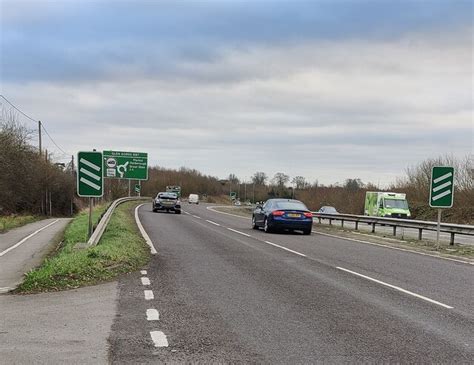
[183,202,474,318]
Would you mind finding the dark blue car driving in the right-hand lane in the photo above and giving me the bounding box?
[252,199,313,235]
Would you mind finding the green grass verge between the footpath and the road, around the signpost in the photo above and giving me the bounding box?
[17,202,149,293]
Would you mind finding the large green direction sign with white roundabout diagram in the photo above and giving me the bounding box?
[104,151,148,180]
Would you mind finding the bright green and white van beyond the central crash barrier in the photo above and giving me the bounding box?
[364,191,411,218]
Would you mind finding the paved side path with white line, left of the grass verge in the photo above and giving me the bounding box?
[0,218,70,293]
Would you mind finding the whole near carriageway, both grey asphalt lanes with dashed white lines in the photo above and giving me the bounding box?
[109,204,474,364]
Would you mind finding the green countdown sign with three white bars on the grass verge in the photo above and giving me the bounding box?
[77,152,104,197]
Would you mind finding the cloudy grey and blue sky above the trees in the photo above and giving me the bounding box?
[0,0,474,186]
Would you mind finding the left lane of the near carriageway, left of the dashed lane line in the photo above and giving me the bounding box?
[111,206,474,363]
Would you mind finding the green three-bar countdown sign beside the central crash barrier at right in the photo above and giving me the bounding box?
[430,166,454,208]
